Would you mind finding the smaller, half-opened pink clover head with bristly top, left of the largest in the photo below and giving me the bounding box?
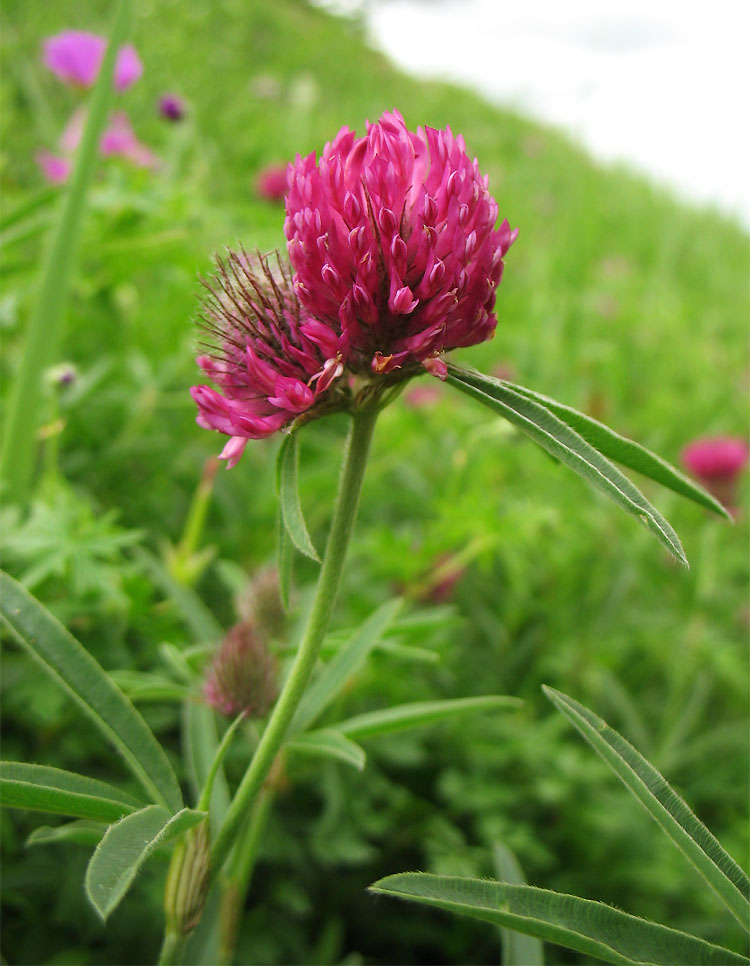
[190,252,343,467]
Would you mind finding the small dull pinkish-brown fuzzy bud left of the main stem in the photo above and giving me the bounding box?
[203,621,276,717]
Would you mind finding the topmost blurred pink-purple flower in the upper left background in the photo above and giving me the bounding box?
[43,30,143,91]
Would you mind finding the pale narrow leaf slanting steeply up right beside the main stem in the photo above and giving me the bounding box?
[290,598,403,735]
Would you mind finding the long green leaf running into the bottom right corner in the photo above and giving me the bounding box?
[370,872,750,966]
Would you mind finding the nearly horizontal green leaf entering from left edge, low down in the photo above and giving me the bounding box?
[0,761,143,822]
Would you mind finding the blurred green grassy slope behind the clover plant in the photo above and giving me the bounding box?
[0,0,750,963]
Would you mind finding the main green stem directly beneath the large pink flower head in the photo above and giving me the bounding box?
[211,406,378,872]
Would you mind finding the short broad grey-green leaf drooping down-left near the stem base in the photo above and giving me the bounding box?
[86,805,206,919]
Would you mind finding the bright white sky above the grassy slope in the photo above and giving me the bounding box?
[318,0,750,224]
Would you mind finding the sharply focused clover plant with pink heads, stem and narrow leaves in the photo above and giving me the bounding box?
[2,85,748,964]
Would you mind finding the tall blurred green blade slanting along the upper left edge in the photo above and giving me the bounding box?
[0,0,132,501]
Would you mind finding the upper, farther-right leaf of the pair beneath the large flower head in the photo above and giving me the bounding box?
[452,368,731,520]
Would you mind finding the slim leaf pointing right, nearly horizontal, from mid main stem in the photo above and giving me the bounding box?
[330,694,523,740]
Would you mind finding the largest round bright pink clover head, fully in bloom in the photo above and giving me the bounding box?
[284,111,517,378]
